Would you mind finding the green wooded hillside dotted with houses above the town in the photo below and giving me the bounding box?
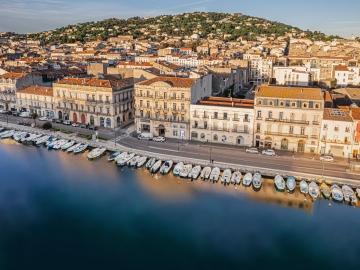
[32,12,342,43]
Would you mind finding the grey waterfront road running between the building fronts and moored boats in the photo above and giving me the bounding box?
[0,114,360,180]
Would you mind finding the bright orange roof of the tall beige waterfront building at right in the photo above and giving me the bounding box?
[255,85,324,100]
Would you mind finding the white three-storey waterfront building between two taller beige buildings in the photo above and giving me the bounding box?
[190,97,254,147]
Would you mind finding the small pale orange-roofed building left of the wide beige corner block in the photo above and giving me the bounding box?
[16,86,55,118]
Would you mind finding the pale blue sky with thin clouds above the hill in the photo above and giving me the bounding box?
[0,0,360,38]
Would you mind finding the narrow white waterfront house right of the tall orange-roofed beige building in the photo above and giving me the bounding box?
[319,108,352,158]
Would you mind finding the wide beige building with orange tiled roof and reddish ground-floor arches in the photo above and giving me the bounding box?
[53,78,134,128]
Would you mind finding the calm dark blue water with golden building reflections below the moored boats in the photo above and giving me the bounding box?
[0,140,360,269]
